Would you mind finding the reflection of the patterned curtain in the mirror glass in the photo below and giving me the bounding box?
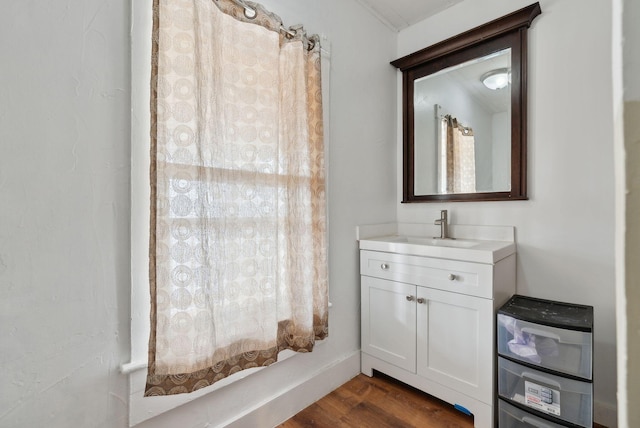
[440,115,476,193]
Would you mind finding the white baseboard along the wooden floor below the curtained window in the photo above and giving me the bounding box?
[220,350,360,428]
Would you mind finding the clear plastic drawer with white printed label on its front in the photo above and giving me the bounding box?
[498,357,593,427]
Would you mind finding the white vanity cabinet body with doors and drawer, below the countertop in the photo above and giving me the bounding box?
[360,243,515,428]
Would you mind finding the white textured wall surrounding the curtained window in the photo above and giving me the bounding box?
[0,0,397,428]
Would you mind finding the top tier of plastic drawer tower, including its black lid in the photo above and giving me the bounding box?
[497,295,593,380]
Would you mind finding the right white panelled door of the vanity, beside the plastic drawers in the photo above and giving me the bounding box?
[417,287,494,404]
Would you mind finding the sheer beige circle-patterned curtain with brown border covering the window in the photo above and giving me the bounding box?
[145,0,328,396]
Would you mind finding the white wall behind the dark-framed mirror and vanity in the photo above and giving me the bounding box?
[398,0,616,426]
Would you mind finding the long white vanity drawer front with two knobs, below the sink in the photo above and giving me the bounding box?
[360,250,493,299]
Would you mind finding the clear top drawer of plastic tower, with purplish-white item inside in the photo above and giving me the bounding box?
[498,314,593,379]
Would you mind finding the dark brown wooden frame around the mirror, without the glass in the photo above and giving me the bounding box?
[391,3,542,203]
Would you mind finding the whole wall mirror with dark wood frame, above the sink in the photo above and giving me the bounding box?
[391,3,541,203]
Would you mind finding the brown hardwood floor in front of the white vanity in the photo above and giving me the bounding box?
[278,373,605,428]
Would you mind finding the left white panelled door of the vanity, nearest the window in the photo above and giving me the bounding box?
[361,276,416,373]
